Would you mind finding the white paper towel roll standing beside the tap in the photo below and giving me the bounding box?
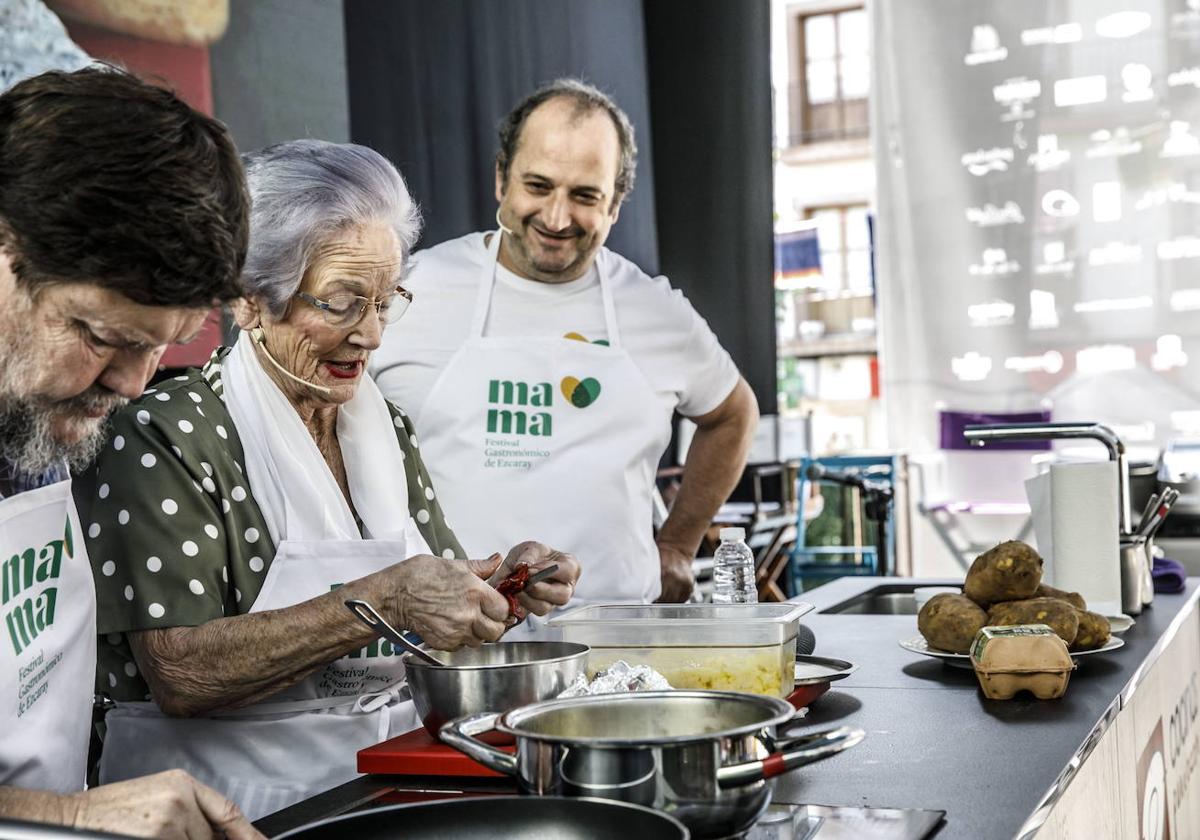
[1025,461,1121,616]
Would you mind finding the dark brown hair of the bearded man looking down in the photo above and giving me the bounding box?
[0,66,250,307]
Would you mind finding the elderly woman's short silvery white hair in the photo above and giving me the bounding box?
[241,140,421,318]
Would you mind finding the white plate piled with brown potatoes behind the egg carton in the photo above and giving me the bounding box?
[900,540,1124,667]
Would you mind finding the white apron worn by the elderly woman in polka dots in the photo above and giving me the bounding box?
[100,540,421,820]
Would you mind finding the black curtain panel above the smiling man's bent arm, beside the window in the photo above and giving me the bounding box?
[648,0,778,414]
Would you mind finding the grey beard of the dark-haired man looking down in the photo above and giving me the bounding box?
[0,330,128,476]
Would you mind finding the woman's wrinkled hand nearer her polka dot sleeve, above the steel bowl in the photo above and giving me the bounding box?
[371,554,509,650]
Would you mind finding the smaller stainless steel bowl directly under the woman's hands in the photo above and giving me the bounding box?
[403,642,589,738]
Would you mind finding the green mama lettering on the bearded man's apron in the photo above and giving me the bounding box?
[0,518,74,654]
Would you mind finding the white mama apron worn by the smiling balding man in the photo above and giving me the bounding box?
[416,233,671,606]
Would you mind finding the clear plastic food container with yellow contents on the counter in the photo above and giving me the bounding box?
[550,604,812,697]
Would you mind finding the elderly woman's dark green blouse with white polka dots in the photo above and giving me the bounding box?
[74,348,464,701]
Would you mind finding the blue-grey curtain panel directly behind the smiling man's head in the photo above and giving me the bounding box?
[346,0,659,274]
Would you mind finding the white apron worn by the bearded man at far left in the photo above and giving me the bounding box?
[0,481,96,793]
